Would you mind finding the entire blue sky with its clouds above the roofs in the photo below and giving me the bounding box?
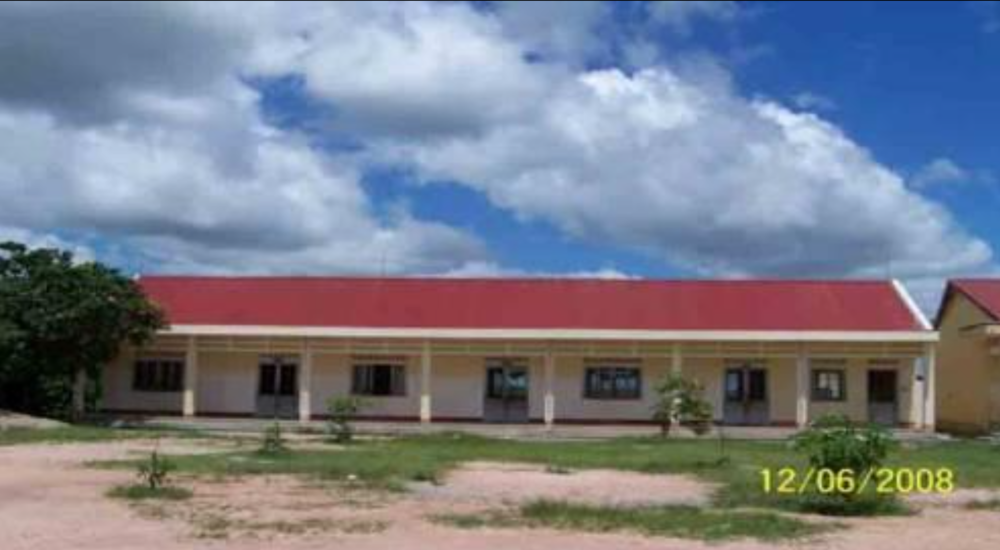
[0,2,1000,308]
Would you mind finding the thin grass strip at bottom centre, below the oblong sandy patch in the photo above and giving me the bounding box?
[431,501,839,541]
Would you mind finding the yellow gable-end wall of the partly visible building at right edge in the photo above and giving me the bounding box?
[937,292,996,432]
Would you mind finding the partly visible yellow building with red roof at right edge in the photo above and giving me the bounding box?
[936,279,1000,433]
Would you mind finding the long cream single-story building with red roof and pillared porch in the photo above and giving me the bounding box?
[103,277,937,430]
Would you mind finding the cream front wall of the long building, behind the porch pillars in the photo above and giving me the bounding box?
[104,344,928,424]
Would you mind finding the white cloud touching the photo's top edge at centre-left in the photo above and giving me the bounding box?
[247,2,547,138]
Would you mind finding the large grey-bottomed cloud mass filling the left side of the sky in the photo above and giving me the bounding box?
[0,3,487,273]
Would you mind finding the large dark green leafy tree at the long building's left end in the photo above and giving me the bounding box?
[0,242,165,416]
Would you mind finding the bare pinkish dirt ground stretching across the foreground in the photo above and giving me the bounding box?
[0,440,1000,550]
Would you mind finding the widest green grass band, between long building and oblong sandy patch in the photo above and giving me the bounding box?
[94,434,1000,515]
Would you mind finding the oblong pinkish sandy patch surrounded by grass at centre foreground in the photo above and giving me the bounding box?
[414,462,713,506]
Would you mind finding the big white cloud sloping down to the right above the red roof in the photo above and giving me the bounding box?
[396,67,991,276]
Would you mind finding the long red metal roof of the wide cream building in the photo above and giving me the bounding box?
[140,277,921,331]
